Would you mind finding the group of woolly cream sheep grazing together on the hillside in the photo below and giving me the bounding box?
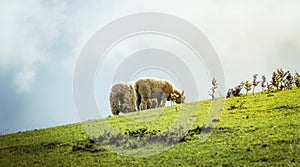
[109,78,185,115]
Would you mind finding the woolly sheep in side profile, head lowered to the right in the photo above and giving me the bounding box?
[134,78,185,110]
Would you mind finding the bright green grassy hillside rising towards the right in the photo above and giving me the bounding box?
[0,88,300,166]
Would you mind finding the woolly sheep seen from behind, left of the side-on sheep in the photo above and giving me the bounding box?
[109,82,137,115]
